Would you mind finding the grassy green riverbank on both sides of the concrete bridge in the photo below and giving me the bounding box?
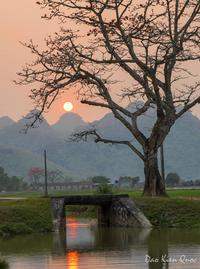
[0,190,200,235]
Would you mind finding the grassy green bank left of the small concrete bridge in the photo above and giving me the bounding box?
[0,198,52,235]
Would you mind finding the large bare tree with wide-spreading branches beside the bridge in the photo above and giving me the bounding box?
[19,0,200,196]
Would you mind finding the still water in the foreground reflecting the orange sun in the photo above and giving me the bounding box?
[0,217,200,269]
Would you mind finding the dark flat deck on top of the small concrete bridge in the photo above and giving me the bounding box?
[51,194,129,205]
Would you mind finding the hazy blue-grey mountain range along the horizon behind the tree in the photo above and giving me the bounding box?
[0,107,200,180]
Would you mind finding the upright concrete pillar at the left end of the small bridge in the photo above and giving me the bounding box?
[51,197,66,232]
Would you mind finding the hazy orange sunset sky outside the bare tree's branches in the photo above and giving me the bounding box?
[0,0,200,123]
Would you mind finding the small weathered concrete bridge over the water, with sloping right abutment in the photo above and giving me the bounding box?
[51,195,151,231]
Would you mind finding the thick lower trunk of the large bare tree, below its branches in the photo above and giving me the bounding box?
[143,150,166,196]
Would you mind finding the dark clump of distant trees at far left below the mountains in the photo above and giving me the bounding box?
[0,167,28,192]
